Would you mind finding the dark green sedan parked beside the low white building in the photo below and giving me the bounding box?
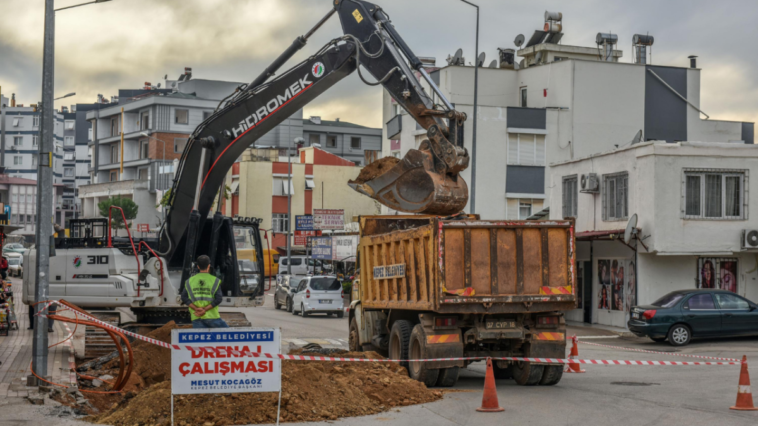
[627,289,758,346]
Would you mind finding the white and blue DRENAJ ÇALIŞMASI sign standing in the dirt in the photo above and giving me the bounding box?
[171,327,282,395]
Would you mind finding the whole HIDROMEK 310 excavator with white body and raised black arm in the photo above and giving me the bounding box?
[24,0,469,356]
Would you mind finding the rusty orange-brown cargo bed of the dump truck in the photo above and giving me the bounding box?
[360,215,576,314]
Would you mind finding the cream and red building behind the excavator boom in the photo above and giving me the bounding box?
[222,147,380,249]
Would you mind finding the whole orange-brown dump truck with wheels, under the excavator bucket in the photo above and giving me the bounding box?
[349,214,577,386]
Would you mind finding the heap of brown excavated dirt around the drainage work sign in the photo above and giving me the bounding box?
[85,323,442,426]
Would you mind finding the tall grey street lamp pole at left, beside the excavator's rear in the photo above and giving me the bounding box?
[30,0,110,390]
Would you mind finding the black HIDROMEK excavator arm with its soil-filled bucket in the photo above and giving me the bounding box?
[160,0,468,272]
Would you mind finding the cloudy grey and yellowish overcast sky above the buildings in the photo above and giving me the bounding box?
[0,0,758,131]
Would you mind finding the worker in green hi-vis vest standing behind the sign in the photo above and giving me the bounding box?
[182,255,229,328]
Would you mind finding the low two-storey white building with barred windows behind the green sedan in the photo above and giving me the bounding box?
[547,141,758,327]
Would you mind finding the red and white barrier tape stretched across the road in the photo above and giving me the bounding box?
[37,302,742,366]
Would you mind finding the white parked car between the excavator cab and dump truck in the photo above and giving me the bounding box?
[292,275,345,318]
